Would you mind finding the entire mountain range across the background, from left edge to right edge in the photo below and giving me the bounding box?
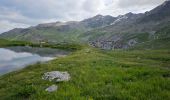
[0,0,170,49]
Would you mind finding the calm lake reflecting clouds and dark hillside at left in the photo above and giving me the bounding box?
[0,47,69,75]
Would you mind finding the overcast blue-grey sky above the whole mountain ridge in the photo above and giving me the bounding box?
[0,0,165,33]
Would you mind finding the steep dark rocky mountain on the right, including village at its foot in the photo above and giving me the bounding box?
[84,0,170,49]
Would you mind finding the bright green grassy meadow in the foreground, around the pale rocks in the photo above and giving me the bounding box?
[0,47,170,100]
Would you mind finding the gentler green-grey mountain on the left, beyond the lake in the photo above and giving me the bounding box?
[0,15,115,42]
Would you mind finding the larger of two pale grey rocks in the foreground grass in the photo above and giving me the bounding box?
[42,71,71,82]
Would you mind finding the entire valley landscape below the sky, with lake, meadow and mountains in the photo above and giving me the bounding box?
[0,0,170,100]
